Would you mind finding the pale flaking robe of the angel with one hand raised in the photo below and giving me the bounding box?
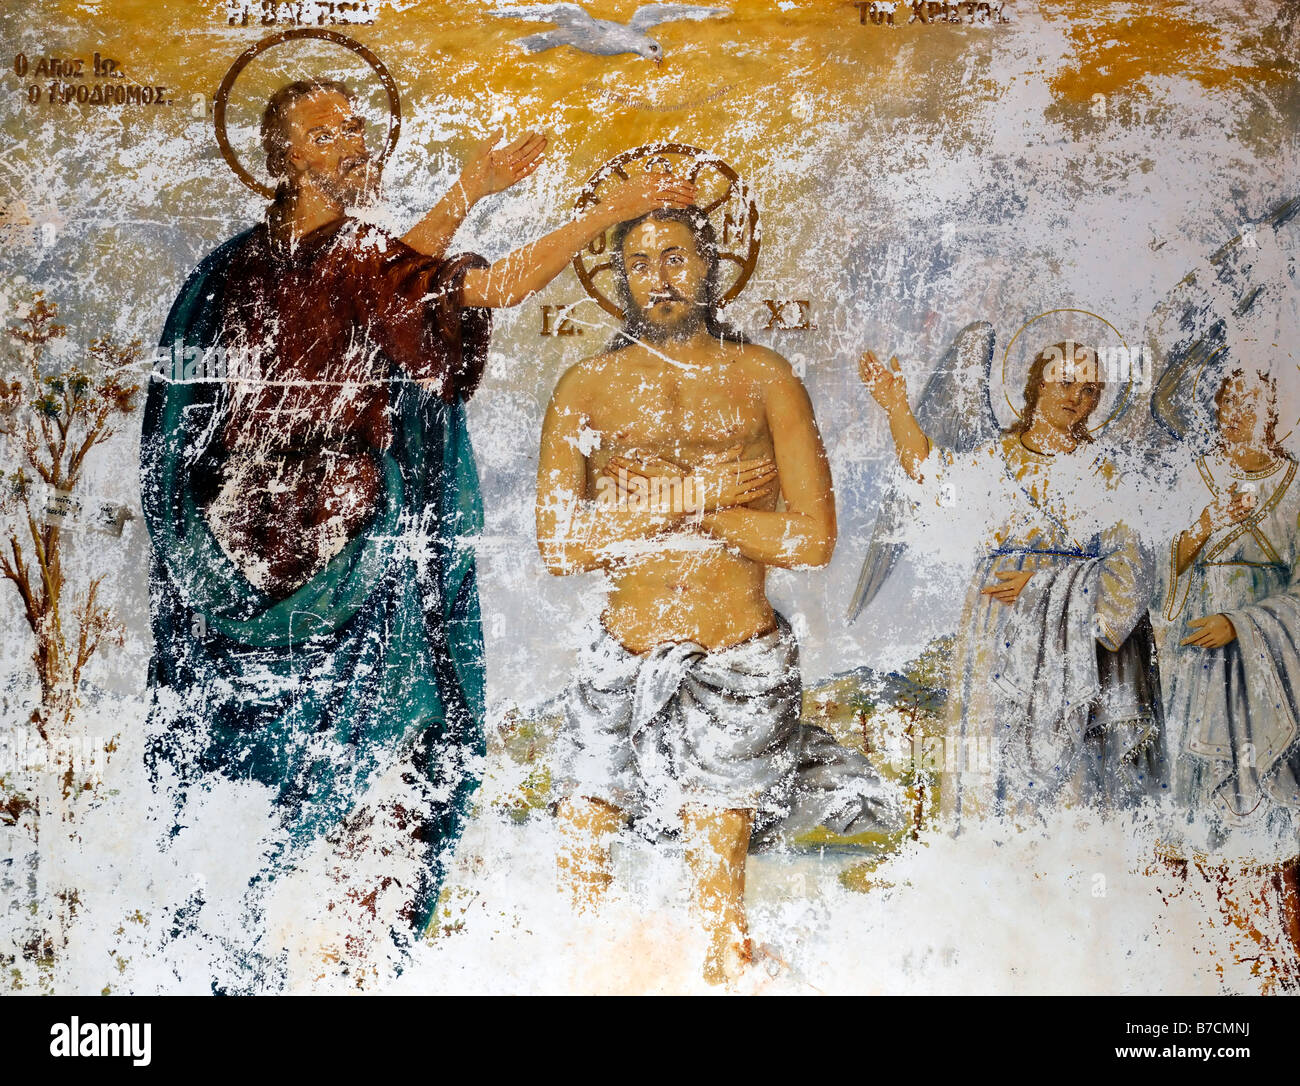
[927,433,1169,825]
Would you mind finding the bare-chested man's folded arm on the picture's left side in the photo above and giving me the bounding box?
[537,369,683,576]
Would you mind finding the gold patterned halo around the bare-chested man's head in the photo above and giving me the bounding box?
[573,142,762,320]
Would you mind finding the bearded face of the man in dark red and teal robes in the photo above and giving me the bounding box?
[285,90,380,207]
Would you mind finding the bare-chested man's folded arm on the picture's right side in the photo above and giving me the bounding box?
[701,371,836,568]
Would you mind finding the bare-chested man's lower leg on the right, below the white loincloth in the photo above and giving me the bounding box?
[681,806,754,985]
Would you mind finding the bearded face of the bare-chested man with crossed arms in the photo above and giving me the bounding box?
[623,219,709,343]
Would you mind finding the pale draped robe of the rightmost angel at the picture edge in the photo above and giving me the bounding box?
[1165,457,1300,862]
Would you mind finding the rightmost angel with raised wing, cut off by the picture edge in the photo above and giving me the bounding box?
[1147,204,1300,991]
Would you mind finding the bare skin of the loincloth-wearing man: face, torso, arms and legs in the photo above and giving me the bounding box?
[537,216,836,981]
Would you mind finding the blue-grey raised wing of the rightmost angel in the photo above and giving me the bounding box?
[1144,196,1300,440]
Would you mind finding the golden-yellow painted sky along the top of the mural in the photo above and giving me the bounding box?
[32,0,1281,210]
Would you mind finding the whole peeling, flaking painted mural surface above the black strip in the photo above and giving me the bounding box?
[0,0,1300,994]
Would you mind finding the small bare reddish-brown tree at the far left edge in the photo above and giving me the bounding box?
[0,291,142,743]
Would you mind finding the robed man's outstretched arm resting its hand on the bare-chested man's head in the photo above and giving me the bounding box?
[464,173,696,310]
